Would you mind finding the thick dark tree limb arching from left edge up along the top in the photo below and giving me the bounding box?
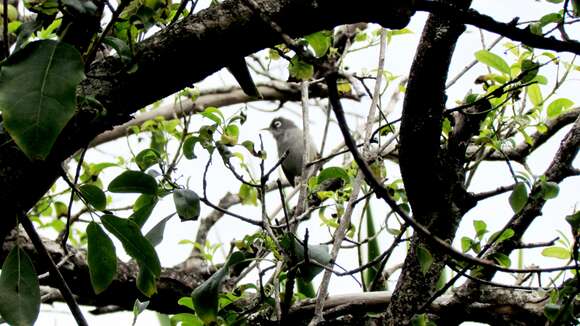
[0,0,413,240]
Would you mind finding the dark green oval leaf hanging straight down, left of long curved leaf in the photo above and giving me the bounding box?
[87,222,117,294]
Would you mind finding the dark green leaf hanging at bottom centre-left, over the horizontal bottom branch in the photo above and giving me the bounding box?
[191,251,245,325]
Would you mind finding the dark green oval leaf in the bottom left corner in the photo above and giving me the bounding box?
[0,247,40,326]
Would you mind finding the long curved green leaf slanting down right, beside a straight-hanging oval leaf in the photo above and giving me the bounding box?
[101,215,161,296]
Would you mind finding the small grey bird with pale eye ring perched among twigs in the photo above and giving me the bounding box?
[265,117,318,187]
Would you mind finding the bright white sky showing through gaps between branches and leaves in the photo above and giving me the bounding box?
[37,0,580,326]
